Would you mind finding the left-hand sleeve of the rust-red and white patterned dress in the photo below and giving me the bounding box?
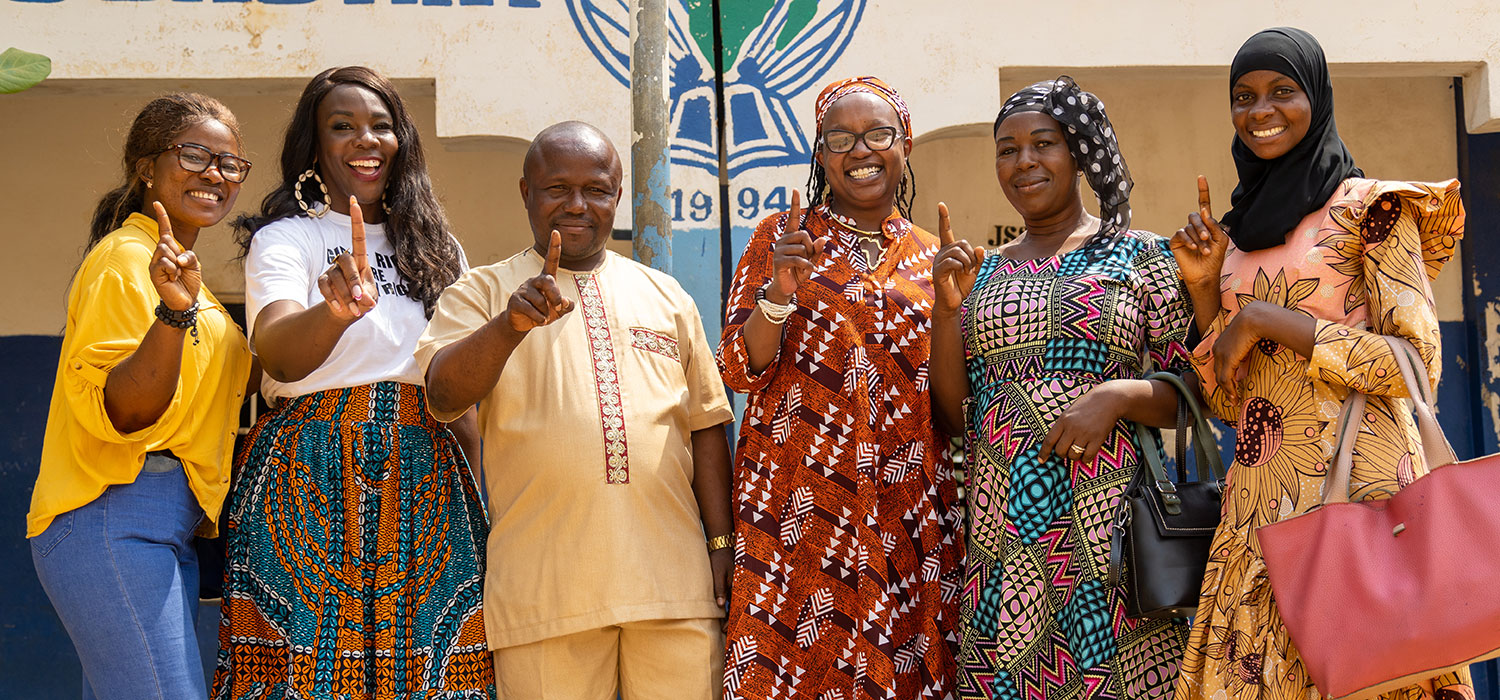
[719,213,788,394]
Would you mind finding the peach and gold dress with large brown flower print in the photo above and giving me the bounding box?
[1175,178,1473,700]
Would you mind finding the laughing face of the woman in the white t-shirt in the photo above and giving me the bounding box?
[318,84,401,222]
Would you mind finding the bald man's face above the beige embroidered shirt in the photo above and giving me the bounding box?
[521,130,623,270]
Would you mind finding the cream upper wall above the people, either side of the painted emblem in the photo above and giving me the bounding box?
[0,0,1500,138]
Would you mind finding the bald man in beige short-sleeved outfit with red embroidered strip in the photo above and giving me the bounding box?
[417,121,734,700]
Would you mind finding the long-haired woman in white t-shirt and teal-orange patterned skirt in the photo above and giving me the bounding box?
[213,67,495,700]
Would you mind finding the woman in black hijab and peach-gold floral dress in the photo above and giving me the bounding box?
[1172,27,1473,700]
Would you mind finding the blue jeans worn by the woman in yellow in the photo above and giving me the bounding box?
[32,457,209,700]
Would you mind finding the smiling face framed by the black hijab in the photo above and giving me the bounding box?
[1229,70,1313,160]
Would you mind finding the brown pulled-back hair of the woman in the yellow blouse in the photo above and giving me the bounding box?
[86,93,243,249]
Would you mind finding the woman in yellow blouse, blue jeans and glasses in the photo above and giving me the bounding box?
[27,93,251,700]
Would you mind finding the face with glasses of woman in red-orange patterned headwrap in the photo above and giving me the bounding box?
[818,93,912,219]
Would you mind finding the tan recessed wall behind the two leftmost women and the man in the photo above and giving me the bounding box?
[0,81,629,336]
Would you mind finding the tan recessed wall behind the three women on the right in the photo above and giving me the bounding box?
[912,69,1463,321]
